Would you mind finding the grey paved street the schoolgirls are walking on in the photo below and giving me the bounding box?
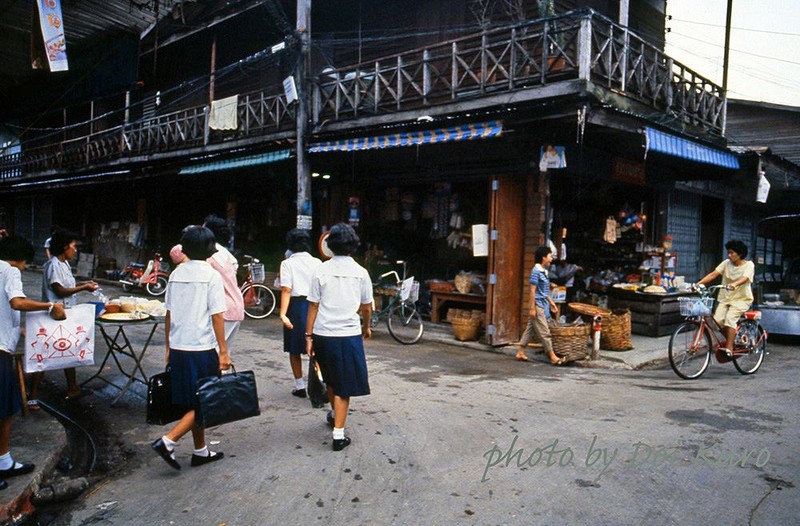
[14,274,800,525]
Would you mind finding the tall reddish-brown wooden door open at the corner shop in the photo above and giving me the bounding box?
[486,176,527,345]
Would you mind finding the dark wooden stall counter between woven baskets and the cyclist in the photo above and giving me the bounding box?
[608,289,691,337]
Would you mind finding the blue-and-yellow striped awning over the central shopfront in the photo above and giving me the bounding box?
[308,121,503,153]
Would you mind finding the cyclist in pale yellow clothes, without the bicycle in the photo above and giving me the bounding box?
[695,241,755,357]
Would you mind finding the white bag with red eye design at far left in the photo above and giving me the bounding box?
[25,304,95,373]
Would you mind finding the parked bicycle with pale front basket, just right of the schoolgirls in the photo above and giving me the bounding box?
[370,261,425,345]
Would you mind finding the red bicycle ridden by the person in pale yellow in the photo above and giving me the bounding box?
[669,285,767,380]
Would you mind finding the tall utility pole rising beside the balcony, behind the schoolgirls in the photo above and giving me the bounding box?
[294,0,313,230]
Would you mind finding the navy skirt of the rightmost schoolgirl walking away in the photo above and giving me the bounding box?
[314,334,369,397]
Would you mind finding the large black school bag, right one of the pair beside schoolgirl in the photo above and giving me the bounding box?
[195,369,261,427]
